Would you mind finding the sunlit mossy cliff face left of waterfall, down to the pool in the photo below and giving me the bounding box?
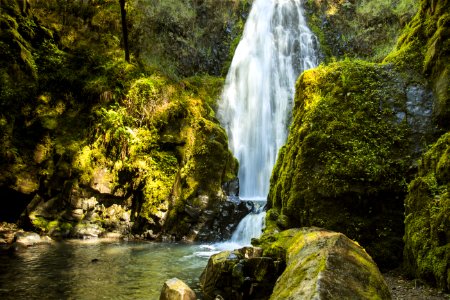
[0,0,247,240]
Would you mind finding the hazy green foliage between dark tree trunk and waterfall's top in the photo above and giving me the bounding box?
[130,0,250,78]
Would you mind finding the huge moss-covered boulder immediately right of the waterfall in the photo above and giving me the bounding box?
[267,60,433,267]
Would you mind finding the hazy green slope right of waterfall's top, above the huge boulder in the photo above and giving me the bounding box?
[305,0,418,61]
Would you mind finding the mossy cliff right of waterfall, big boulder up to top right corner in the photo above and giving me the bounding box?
[267,1,449,276]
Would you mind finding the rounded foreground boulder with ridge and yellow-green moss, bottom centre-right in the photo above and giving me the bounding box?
[262,227,391,300]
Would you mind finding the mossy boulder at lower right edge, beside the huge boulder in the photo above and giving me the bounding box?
[404,133,450,291]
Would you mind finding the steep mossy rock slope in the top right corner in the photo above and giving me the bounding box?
[385,0,450,130]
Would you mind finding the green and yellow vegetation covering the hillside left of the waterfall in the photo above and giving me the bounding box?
[0,0,249,238]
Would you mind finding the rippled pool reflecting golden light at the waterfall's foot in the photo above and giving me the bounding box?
[0,241,212,299]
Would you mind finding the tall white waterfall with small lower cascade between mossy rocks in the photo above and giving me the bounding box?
[218,0,317,244]
